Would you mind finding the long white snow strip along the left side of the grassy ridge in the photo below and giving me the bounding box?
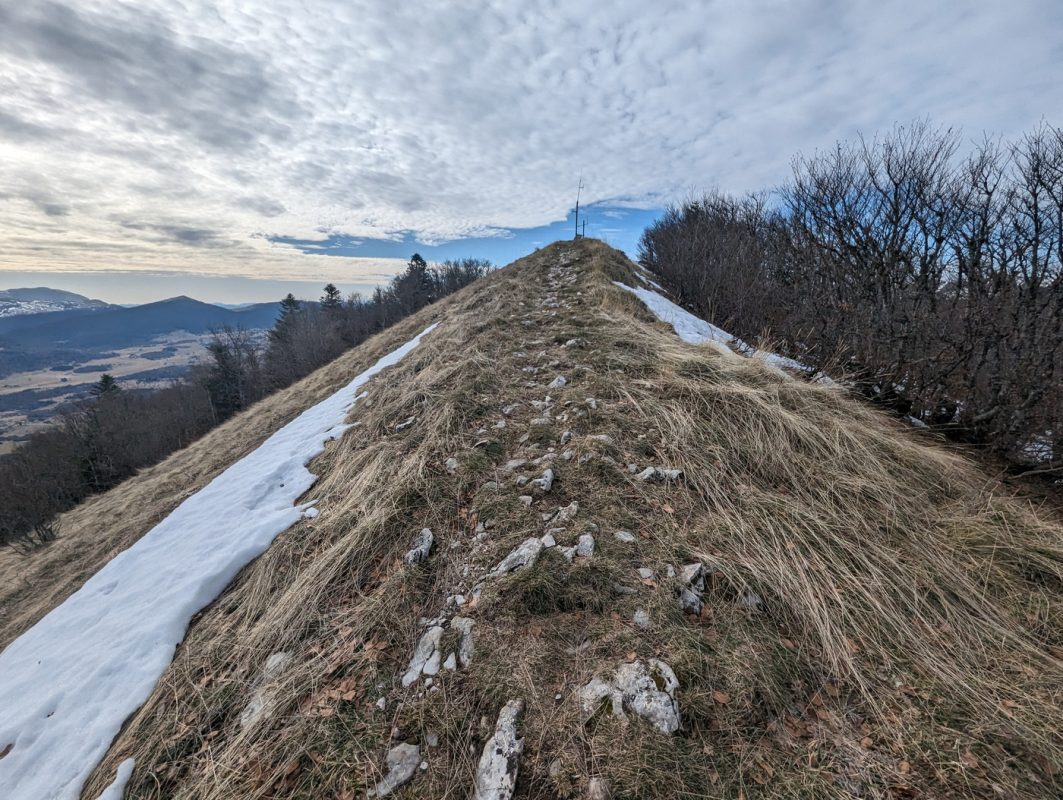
[0,325,435,800]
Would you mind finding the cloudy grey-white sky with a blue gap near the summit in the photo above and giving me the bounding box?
[0,0,1063,299]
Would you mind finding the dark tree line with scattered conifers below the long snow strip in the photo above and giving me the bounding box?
[0,255,491,549]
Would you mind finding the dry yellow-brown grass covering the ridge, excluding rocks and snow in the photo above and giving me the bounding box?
[8,241,1063,798]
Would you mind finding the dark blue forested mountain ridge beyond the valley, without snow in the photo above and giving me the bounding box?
[0,296,280,350]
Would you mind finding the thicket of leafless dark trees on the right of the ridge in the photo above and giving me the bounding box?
[640,123,1063,463]
